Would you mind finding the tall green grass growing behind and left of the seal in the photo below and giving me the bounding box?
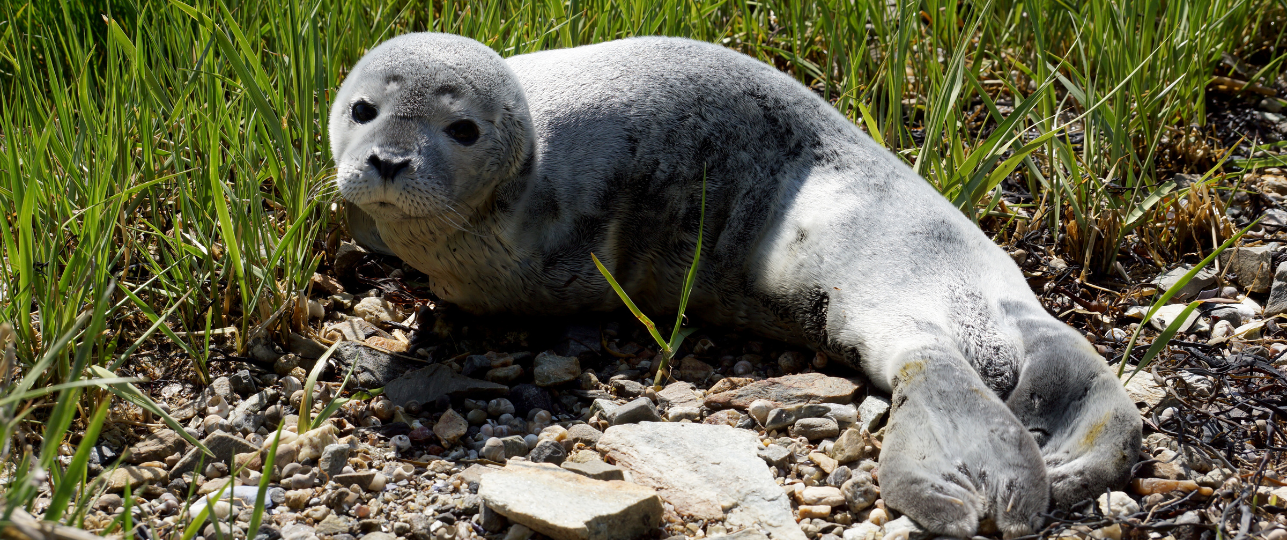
[0,0,1284,532]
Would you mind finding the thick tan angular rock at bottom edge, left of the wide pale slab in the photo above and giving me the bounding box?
[479,465,664,540]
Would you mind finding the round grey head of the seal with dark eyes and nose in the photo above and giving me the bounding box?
[331,33,535,222]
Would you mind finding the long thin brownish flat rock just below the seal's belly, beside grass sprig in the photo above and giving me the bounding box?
[705,373,861,409]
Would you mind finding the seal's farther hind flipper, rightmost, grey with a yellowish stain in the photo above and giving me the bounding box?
[1006,323,1143,508]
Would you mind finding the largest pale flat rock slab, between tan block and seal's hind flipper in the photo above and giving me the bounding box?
[597,421,797,540]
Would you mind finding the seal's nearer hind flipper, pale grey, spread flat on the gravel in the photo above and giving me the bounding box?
[879,348,1049,537]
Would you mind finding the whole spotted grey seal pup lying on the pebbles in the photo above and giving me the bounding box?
[329,33,1142,536]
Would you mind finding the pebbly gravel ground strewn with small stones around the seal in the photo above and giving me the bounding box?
[36,221,1287,540]
